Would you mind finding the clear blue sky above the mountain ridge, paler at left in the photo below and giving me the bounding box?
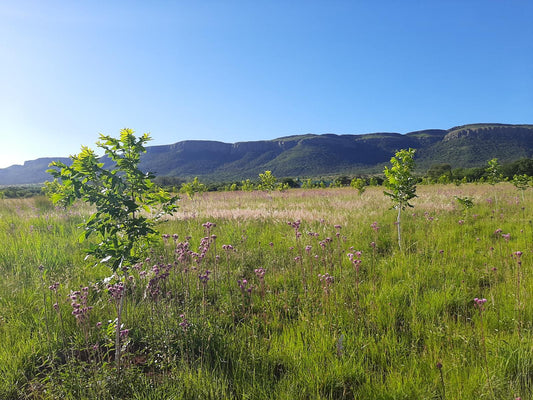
[0,0,533,167]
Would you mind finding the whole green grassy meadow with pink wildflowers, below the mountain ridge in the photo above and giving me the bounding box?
[0,183,533,400]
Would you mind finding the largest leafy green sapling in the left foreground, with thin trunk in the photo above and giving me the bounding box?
[48,129,178,369]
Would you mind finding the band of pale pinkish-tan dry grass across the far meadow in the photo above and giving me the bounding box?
[167,183,518,224]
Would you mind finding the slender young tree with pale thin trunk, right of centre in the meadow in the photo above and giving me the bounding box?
[383,149,417,250]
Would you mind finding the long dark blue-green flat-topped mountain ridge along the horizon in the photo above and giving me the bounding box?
[0,124,533,185]
